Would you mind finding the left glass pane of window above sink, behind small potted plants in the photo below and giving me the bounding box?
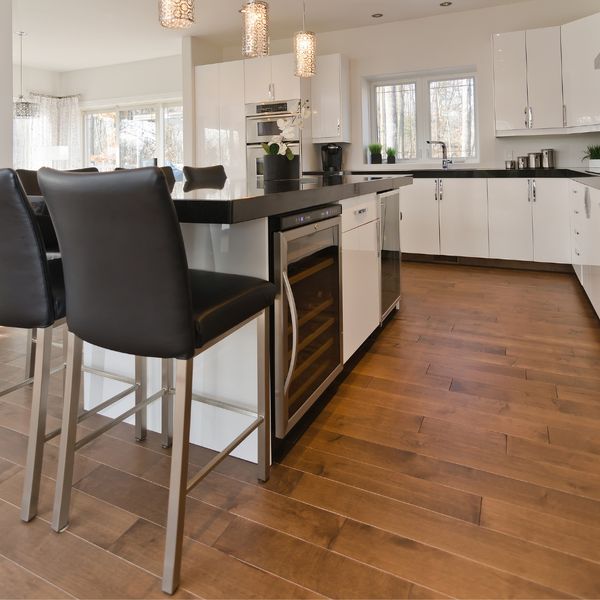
[375,83,417,160]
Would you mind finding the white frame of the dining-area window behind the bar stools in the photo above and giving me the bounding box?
[81,98,183,167]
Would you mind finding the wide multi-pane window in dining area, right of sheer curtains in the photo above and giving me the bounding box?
[84,104,183,175]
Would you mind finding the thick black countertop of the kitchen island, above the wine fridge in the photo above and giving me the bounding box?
[173,173,412,224]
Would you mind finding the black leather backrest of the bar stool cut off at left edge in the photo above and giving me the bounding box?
[0,169,60,329]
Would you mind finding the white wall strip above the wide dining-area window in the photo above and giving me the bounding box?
[60,55,183,106]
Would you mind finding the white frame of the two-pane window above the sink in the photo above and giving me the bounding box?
[365,69,480,165]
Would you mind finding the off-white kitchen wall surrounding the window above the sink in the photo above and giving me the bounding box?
[223,0,600,169]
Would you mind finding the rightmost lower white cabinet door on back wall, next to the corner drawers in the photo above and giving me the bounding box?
[532,177,571,264]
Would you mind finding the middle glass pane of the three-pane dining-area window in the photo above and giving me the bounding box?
[119,107,157,169]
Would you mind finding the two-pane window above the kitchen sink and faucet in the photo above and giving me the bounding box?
[371,75,478,162]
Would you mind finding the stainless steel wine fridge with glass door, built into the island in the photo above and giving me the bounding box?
[273,205,343,438]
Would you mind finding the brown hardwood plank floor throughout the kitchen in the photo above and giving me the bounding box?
[0,264,600,598]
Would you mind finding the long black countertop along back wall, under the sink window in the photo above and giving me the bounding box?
[352,167,597,179]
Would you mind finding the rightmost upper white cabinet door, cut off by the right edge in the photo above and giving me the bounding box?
[562,13,600,127]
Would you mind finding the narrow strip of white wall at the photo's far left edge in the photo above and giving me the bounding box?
[0,0,13,168]
